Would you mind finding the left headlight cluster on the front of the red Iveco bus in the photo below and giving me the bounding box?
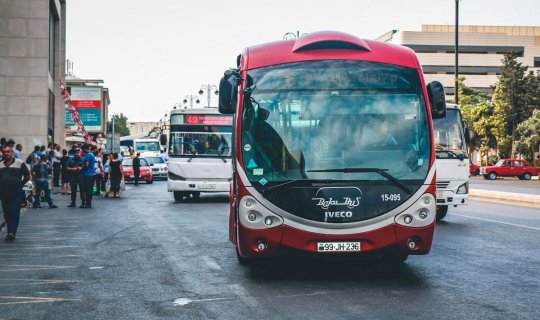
[238,196,283,229]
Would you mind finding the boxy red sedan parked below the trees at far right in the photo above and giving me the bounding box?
[480,159,540,180]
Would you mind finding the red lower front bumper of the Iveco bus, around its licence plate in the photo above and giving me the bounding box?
[237,223,435,258]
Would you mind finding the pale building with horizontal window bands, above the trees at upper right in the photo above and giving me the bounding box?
[400,25,540,95]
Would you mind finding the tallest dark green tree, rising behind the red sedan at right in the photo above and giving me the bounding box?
[492,52,537,157]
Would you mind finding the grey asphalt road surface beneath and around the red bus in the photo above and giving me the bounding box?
[0,183,540,320]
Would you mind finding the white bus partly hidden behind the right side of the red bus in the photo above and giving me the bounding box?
[433,104,470,220]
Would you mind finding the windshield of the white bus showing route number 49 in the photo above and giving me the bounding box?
[169,121,232,158]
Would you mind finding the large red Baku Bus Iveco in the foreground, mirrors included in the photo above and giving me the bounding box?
[219,31,446,263]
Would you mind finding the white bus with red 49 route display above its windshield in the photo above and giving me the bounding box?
[167,108,233,202]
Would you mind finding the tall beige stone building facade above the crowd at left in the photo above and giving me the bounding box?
[0,0,66,154]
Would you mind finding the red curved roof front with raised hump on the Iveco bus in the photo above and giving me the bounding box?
[242,31,421,70]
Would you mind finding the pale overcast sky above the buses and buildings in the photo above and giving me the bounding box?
[66,0,540,122]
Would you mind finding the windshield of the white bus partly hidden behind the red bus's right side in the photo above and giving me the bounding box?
[433,108,467,159]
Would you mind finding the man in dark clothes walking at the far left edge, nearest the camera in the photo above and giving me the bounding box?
[0,146,30,241]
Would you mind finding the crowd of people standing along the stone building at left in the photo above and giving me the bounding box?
[0,138,129,241]
